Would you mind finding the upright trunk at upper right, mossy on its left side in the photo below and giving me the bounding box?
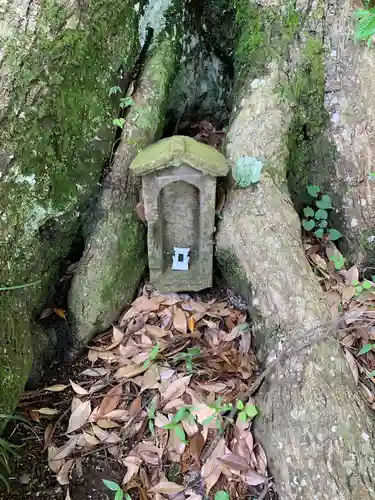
[279,0,375,263]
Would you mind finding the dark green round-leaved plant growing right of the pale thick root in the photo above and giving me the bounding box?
[302,185,342,241]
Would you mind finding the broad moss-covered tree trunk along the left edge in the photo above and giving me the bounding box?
[0,0,139,410]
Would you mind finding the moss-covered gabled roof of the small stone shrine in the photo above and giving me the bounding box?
[130,135,229,177]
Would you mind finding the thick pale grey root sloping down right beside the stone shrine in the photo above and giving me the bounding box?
[217,2,375,500]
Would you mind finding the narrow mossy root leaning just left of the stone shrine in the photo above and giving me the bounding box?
[69,18,185,347]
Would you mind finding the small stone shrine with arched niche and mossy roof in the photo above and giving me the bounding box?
[130,136,229,292]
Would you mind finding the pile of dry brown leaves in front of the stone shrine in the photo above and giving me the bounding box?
[23,289,269,500]
